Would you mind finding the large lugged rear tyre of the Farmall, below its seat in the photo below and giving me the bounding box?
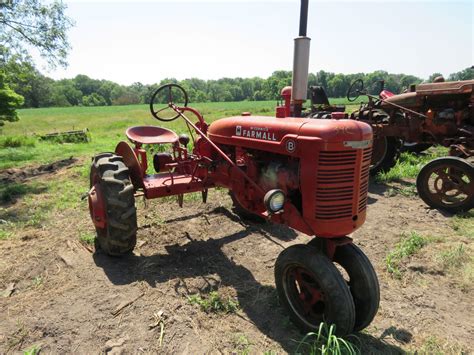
[90,153,137,255]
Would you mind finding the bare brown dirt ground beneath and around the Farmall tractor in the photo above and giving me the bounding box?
[0,162,474,354]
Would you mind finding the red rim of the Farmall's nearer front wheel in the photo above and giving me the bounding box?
[283,265,327,327]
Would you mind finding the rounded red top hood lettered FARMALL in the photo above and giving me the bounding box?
[208,116,372,154]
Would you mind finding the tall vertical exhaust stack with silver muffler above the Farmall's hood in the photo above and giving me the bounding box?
[291,0,311,117]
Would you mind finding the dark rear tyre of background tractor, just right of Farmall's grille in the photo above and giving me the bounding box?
[370,137,401,175]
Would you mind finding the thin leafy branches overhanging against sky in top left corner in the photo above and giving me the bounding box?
[0,0,73,67]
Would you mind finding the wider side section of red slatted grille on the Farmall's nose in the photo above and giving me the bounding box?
[315,150,357,220]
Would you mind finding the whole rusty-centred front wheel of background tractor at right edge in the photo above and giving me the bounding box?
[416,157,474,213]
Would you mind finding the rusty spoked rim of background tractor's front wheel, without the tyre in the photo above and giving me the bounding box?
[425,163,474,207]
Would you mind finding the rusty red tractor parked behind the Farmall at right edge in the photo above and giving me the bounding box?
[306,78,474,213]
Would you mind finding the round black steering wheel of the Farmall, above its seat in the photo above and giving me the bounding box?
[150,84,188,122]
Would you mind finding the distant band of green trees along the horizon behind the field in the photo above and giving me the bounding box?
[5,60,474,107]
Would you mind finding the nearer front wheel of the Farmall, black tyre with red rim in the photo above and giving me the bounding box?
[275,244,355,335]
